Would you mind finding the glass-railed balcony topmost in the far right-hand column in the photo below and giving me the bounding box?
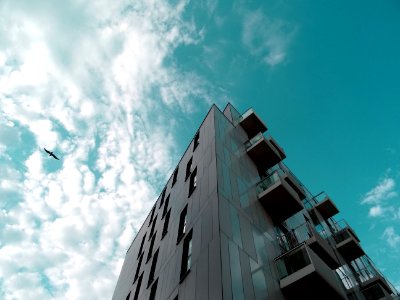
[309,193,339,224]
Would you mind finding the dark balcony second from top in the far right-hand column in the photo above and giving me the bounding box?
[333,220,365,261]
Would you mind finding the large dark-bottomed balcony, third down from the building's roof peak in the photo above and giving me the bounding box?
[256,169,303,224]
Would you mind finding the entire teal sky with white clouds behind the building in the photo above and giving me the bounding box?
[0,0,400,299]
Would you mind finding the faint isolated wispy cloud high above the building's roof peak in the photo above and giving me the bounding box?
[242,10,297,66]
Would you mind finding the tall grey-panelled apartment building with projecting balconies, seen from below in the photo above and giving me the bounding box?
[113,104,398,300]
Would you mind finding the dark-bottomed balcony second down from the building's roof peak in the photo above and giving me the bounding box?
[245,133,286,170]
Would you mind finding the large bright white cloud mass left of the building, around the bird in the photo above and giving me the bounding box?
[0,0,219,299]
